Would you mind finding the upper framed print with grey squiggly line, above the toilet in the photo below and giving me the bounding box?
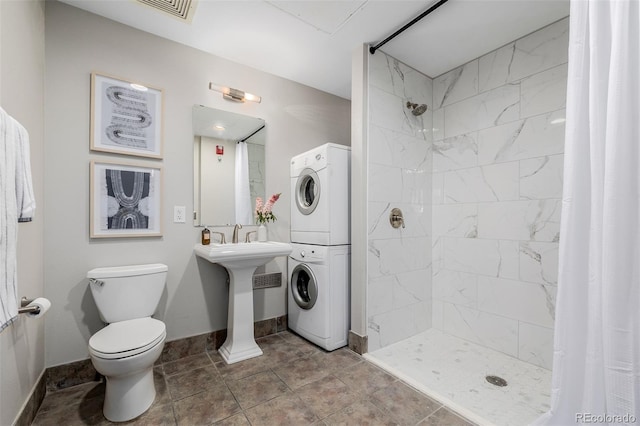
[91,73,163,158]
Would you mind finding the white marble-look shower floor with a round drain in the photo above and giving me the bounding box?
[365,329,551,426]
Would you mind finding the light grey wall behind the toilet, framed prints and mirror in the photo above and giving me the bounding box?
[44,1,350,366]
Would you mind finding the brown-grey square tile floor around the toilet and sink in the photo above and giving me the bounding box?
[33,331,478,426]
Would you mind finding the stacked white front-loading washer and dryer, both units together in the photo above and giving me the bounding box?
[287,143,351,351]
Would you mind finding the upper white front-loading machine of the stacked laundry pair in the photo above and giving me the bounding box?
[291,143,351,246]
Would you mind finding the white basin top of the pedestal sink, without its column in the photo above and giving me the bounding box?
[195,241,292,268]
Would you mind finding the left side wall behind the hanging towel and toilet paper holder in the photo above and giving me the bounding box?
[0,0,45,425]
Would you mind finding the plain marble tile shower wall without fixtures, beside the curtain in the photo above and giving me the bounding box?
[432,19,569,368]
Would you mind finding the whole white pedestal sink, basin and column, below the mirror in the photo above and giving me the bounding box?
[194,241,292,364]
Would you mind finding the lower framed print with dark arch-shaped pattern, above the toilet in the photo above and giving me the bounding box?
[90,161,162,238]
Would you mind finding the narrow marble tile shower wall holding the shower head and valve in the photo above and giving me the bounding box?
[367,51,433,351]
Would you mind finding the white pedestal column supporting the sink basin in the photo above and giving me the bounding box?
[218,267,262,364]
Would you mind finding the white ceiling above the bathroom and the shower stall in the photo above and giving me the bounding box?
[62,0,569,99]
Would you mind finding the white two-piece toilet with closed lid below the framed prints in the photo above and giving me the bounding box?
[87,263,168,422]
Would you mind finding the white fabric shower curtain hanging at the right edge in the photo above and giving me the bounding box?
[536,0,640,425]
